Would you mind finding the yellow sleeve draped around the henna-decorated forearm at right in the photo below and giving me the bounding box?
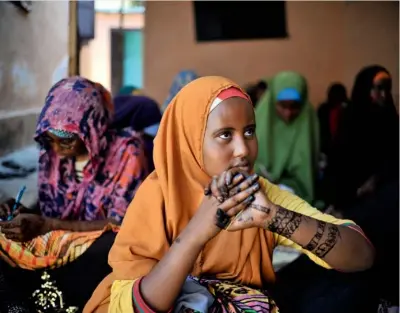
[265,178,369,269]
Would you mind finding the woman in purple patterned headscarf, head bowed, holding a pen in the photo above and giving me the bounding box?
[0,77,147,312]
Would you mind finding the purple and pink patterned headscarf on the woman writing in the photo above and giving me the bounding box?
[35,77,147,221]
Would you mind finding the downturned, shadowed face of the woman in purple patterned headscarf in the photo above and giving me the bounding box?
[43,132,87,158]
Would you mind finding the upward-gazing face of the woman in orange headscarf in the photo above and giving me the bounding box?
[203,97,258,176]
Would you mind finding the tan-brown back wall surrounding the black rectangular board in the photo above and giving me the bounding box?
[144,1,399,104]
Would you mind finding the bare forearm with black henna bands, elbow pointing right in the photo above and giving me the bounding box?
[229,199,375,272]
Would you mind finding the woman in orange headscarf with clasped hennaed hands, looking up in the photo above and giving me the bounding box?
[84,77,374,313]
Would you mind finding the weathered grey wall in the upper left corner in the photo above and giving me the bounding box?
[0,0,69,155]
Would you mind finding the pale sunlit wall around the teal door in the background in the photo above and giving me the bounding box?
[80,12,144,90]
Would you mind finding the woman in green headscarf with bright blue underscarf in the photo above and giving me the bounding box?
[255,71,319,203]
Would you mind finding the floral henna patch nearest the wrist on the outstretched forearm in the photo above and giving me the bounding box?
[265,206,303,239]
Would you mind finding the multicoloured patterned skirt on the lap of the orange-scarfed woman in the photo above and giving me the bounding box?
[180,277,279,313]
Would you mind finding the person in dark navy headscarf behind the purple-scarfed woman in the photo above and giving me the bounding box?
[112,95,161,172]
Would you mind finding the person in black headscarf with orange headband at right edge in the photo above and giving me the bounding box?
[326,65,399,213]
